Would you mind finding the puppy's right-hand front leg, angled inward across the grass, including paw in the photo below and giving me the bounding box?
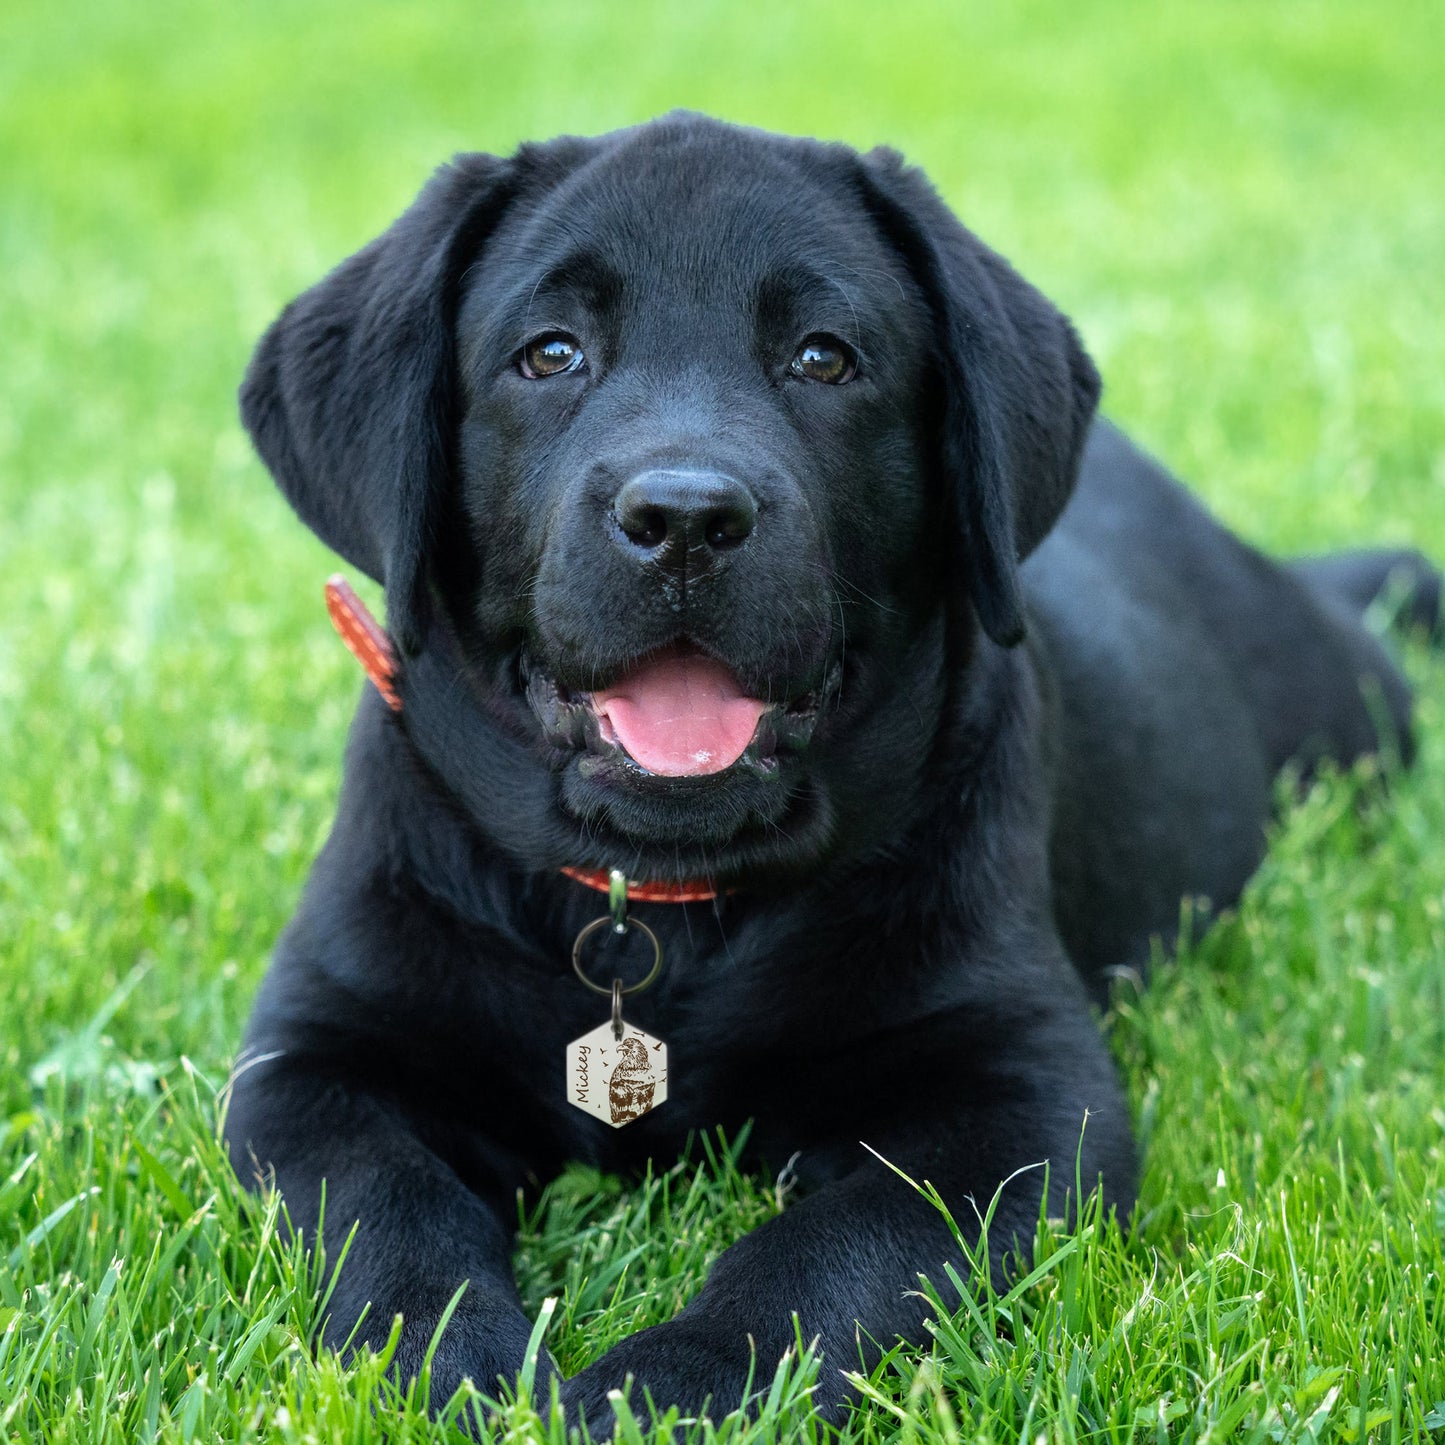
[551,1010,1133,1432]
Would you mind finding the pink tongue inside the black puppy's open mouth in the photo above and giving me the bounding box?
[592,652,767,777]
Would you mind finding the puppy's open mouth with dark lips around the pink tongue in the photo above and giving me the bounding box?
[523,642,838,777]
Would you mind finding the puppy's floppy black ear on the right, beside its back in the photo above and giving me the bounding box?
[858,149,1100,646]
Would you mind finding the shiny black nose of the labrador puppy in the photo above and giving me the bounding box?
[613,471,757,574]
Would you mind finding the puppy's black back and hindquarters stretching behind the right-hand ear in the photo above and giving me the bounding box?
[1023,423,1433,997]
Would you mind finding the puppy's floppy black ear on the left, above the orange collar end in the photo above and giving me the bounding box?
[240,155,516,653]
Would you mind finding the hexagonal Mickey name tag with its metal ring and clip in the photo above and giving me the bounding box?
[566,873,668,1129]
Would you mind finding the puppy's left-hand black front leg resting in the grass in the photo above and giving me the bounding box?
[227,1053,551,1409]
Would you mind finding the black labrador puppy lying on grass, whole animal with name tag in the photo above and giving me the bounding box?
[228,116,1439,1420]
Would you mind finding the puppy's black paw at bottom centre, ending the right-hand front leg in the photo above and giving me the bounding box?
[562,1319,757,1433]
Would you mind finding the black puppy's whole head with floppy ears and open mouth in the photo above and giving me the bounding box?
[241,116,1098,877]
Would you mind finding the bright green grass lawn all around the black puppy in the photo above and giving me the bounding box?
[0,0,1445,1442]
